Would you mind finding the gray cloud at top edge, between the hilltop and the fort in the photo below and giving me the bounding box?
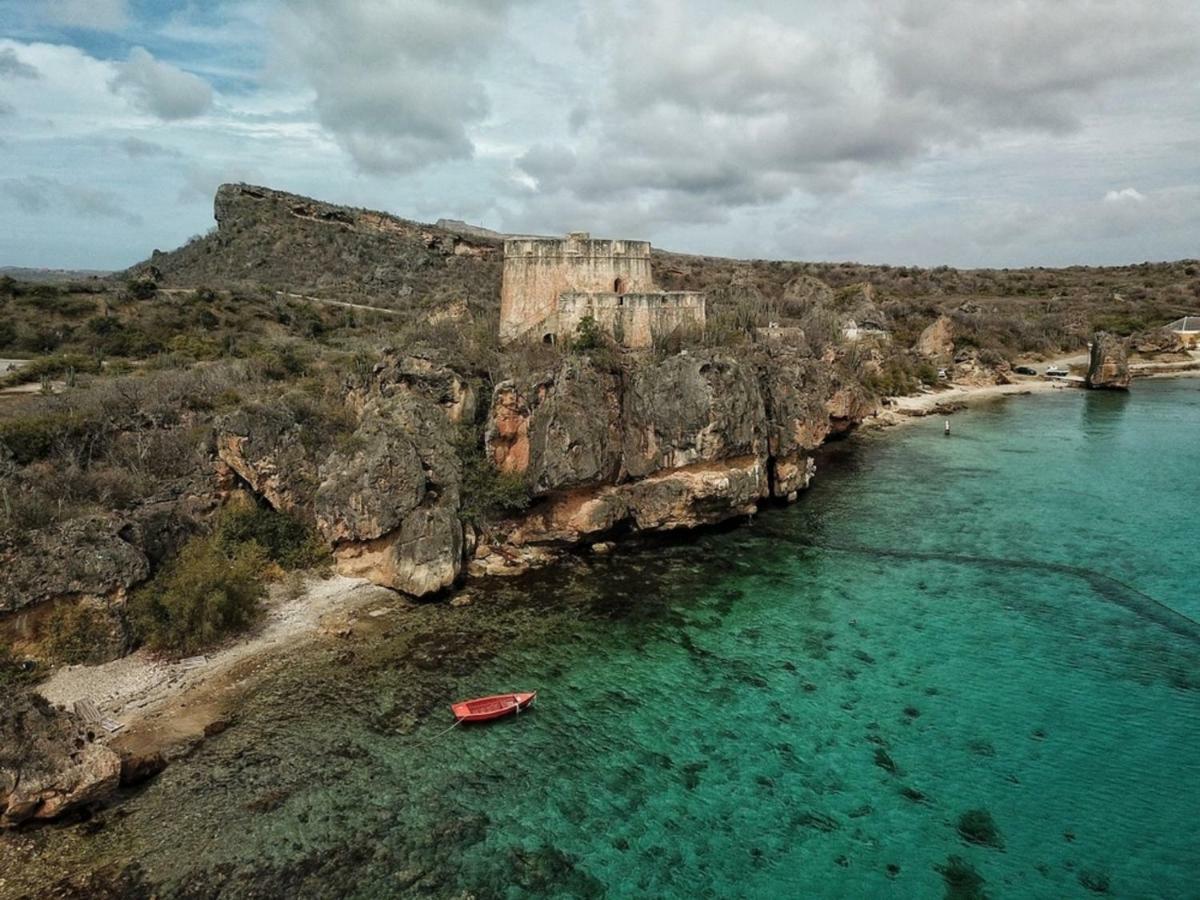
[281,0,525,173]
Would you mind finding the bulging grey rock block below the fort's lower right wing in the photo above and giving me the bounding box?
[622,352,767,479]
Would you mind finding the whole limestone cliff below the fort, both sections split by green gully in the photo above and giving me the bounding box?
[217,346,872,595]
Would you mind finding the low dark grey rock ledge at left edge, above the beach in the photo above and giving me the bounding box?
[0,516,150,614]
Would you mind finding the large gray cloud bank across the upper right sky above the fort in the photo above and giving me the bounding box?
[511,0,1200,236]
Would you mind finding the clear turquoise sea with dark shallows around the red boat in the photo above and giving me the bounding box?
[0,380,1200,898]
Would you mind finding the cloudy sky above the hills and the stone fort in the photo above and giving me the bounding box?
[0,0,1200,268]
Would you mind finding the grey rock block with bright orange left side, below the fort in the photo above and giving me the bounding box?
[487,358,622,494]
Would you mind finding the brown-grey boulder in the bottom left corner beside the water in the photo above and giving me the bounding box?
[0,690,121,827]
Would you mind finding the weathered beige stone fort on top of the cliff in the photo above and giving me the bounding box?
[500,232,704,349]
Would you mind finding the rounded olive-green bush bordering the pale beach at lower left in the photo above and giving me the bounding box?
[130,536,268,654]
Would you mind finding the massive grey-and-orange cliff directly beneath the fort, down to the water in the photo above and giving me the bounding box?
[481,346,874,553]
